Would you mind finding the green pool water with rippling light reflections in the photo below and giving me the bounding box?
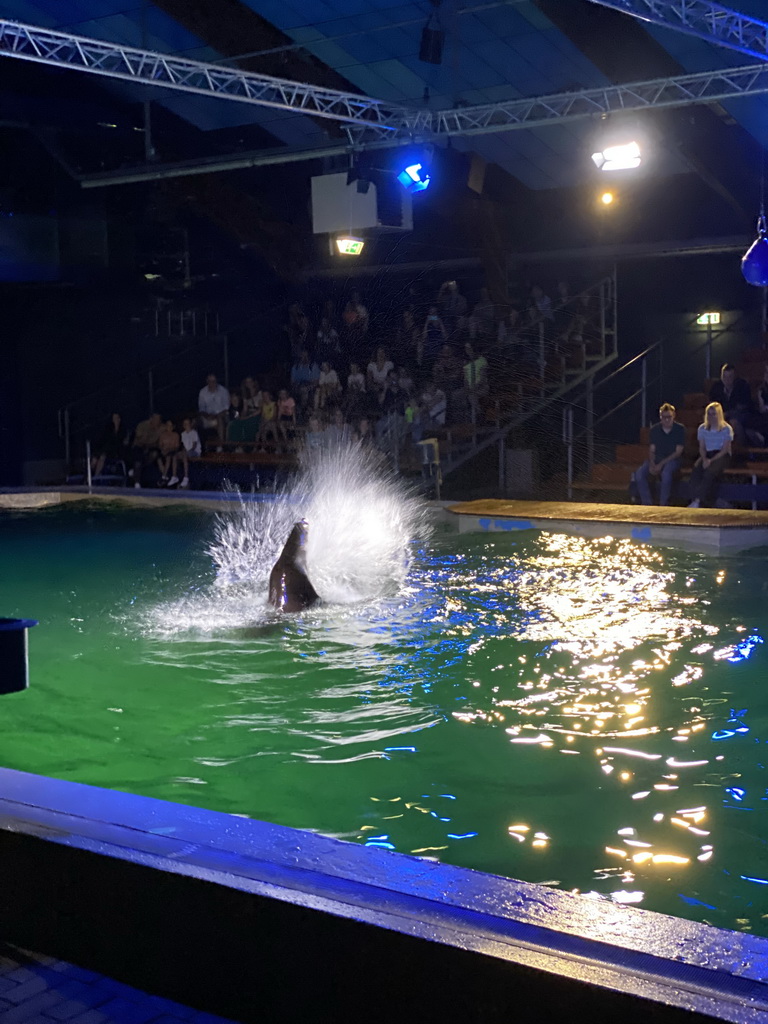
[0,504,768,935]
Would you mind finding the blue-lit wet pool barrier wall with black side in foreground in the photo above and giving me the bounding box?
[0,769,768,1024]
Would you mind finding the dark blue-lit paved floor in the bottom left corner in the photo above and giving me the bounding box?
[0,942,240,1024]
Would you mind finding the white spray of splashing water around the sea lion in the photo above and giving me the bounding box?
[208,444,429,604]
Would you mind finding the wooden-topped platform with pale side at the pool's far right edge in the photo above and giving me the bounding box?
[447,499,768,554]
